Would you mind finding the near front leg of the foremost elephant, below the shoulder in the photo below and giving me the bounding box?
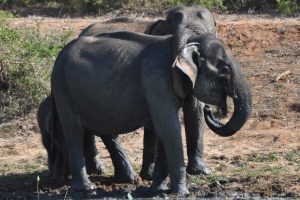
[151,105,189,194]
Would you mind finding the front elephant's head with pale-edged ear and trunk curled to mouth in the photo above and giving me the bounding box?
[172,34,252,137]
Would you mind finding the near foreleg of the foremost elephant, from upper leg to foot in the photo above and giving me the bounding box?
[148,99,189,194]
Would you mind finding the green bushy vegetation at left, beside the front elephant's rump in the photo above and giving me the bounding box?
[0,18,71,119]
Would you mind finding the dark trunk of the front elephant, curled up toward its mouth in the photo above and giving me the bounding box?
[204,79,252,137]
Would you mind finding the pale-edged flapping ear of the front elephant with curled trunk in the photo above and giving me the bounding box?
[171,43,200,99]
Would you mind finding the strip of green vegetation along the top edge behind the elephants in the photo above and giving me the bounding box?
[0,0,300,16]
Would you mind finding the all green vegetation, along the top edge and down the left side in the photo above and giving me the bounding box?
[0,0,300,119]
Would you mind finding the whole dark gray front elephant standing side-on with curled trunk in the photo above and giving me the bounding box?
[51,32,251,194]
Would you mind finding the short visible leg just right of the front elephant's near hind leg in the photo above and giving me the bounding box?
[84,134,105,174]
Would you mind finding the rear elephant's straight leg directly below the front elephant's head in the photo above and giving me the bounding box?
[183,96,211,174]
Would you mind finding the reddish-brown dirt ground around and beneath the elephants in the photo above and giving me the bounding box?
[0,15,300,199]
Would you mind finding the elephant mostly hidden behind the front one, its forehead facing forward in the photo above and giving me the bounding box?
[79,5,216,180]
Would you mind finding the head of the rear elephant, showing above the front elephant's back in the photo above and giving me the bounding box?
[146,5,216,58]
